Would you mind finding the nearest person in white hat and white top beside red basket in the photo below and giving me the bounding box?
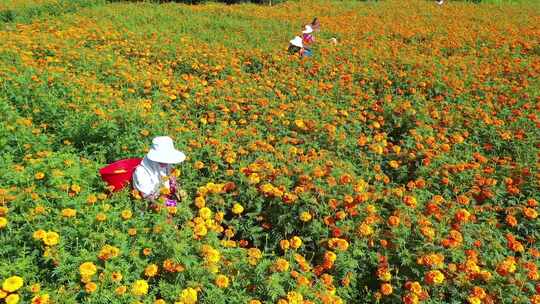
[133,136,186,206]
